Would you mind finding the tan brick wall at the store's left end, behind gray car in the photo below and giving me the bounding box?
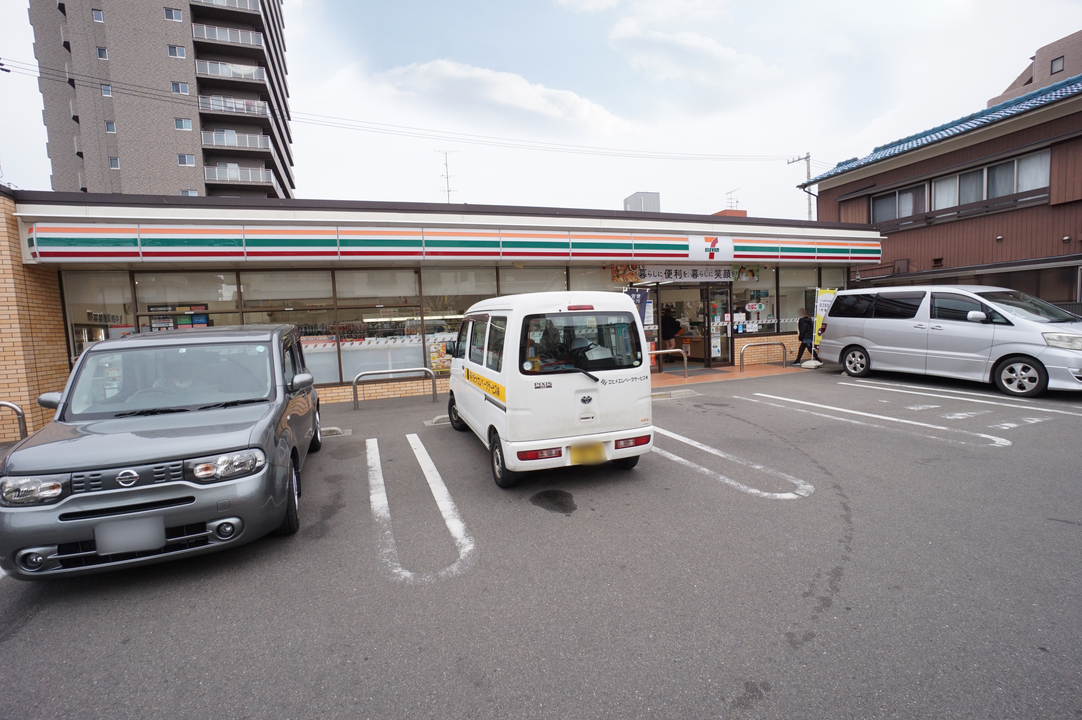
[0,188,68,442]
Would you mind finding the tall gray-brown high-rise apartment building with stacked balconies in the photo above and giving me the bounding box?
[29,0,294,197]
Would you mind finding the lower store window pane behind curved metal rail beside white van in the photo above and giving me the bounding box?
[338,307,425,382]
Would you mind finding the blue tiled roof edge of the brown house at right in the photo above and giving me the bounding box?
[797,75,1082,187]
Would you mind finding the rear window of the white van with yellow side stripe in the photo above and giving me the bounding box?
[518,312,643,375]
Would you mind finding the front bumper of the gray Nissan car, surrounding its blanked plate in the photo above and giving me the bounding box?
[0,464,285,580]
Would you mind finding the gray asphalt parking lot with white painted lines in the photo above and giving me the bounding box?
[0,367,1082,719]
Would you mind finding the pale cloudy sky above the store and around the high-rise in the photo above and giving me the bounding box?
[0,0,1082,219]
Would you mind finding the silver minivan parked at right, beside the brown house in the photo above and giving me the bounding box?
[819,285,1082,396]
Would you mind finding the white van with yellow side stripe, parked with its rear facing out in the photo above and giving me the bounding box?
[447,292,654,487]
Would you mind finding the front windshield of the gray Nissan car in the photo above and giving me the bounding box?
[65,342,274,419]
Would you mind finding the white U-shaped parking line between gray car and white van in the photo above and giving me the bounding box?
[365,434,476,582]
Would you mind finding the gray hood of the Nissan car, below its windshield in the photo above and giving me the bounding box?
[2,405,273,475]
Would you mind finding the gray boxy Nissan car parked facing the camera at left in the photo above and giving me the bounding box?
[0,325,322,580]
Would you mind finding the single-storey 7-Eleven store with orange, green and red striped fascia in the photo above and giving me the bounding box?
[0,186,880,438]
